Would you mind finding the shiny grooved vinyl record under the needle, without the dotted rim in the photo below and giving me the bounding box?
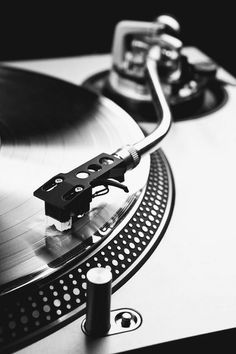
[0,68,149,292]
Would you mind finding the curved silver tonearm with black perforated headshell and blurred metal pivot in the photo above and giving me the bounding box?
[34,17,181,226]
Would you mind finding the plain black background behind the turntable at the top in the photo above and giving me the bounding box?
[0,0,236,75]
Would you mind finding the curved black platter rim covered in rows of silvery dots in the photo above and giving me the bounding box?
[0,151,174,350]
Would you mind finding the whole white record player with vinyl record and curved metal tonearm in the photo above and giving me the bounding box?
[0,15,236,354]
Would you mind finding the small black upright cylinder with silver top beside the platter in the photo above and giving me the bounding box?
[85,268,112,337]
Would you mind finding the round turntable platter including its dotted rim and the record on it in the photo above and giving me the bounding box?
[0,67,174,352]
